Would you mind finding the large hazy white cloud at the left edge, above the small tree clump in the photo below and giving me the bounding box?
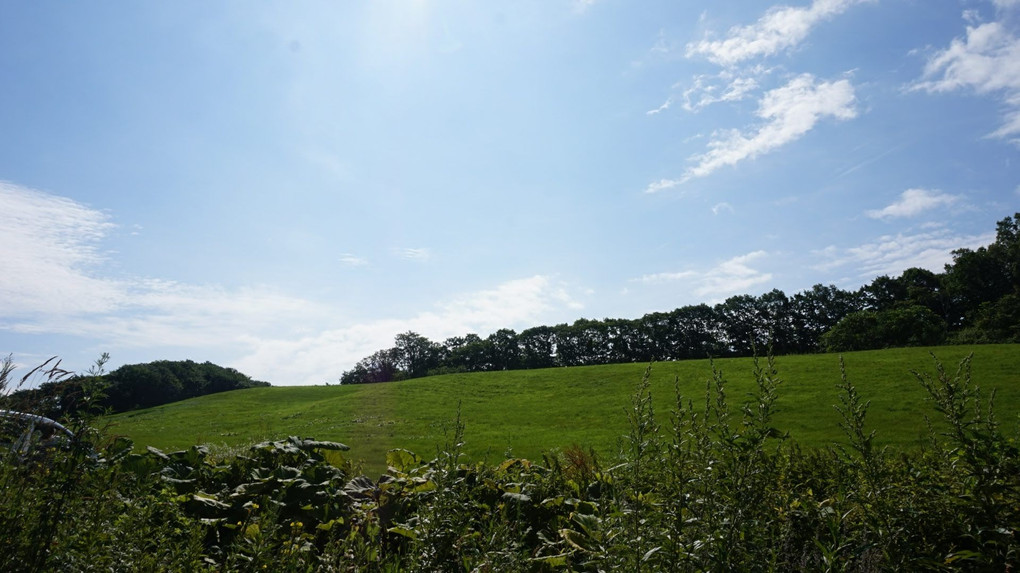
[0,184,320,348]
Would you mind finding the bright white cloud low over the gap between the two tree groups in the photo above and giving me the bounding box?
[234,275,581,385]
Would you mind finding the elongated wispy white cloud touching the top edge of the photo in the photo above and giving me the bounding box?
[686,0,868,66]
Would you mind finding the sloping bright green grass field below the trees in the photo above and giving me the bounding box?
[108,345,1020,473]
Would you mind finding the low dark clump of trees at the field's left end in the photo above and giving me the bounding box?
[0,355,269,420]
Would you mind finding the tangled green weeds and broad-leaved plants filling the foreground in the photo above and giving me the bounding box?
[0,360,1020,571]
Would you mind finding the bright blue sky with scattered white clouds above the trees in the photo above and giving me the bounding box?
[0,0,1020,384]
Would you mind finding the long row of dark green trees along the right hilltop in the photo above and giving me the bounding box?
[340,212,1020,384]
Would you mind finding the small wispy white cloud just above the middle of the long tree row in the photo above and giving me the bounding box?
[633,251,772,302]
